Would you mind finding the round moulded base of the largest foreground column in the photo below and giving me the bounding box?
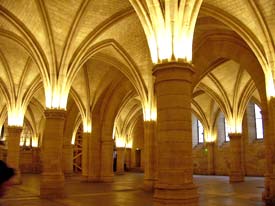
[154,183,199,206]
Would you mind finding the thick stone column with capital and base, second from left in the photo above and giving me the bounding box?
[40,109,66,198]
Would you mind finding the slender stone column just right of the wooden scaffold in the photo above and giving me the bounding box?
[81,132,91,181]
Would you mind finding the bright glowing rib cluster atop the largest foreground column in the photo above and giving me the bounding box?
[130,0,202,64]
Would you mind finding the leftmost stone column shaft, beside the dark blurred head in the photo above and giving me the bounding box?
[7,126,22,184]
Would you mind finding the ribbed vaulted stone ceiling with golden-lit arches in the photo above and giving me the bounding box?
[0,0,275,145]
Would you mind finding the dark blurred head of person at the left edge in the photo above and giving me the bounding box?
[0,160,14,197]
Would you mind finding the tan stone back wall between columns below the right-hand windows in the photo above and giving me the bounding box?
[193,105,265,176]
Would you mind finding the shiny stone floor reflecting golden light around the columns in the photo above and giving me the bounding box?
[0,173,264,206]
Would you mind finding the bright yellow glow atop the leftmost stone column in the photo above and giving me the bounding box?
[8,106,24,127]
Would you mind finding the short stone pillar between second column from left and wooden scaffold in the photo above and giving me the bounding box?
[62,144,74,176]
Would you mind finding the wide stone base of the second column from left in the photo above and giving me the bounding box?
[40,174,65,198]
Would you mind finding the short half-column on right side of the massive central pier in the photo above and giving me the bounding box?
[100,139,114,182]
